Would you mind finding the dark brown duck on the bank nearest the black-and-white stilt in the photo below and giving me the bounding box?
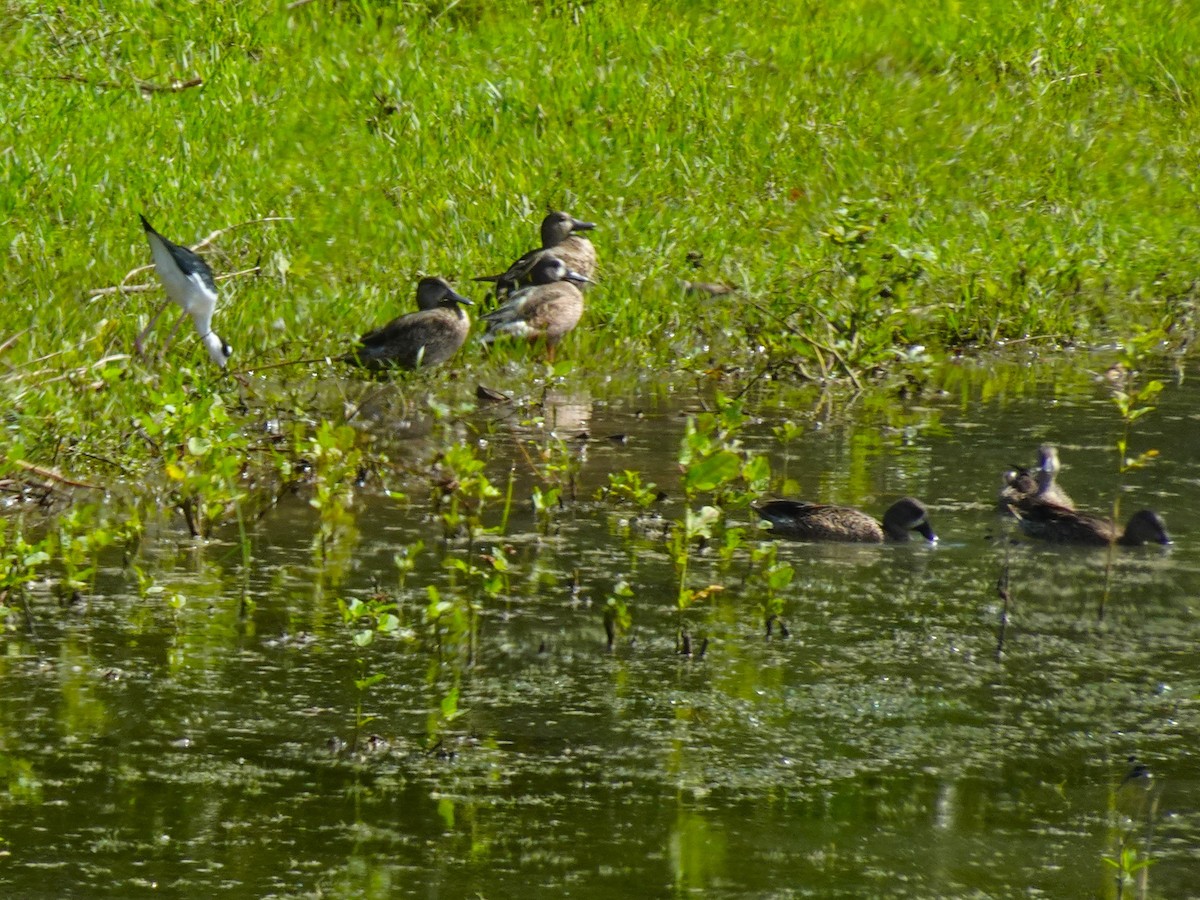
[341,278,473,370]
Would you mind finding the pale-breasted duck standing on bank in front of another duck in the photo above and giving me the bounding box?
[481,256,592,356]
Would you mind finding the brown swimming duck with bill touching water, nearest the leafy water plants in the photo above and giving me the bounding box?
[754,497,937,544]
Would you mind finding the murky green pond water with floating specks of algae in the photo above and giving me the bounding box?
[0,360,1200,898]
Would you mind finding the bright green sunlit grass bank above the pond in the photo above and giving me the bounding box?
[0,0,1200,487]
